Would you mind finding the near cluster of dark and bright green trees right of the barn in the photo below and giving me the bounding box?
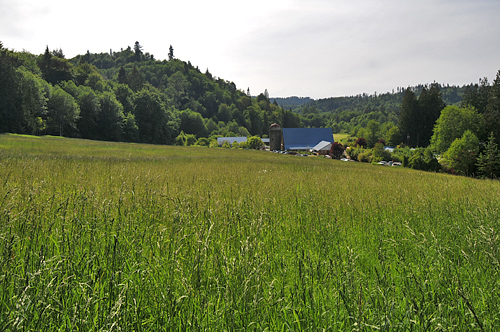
[340,71,500,178]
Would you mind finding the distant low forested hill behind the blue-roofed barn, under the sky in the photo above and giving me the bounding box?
[271,83,467,136]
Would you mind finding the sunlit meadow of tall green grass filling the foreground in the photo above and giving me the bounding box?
[0,135,500,331]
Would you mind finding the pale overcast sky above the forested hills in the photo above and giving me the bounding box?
[0,0,500,99]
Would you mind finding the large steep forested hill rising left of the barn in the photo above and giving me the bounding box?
[0,42,301,145]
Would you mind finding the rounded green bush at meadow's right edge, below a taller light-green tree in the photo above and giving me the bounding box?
[443,130,479,176]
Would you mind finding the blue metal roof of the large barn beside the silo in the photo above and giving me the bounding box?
[283,128,333,150]
